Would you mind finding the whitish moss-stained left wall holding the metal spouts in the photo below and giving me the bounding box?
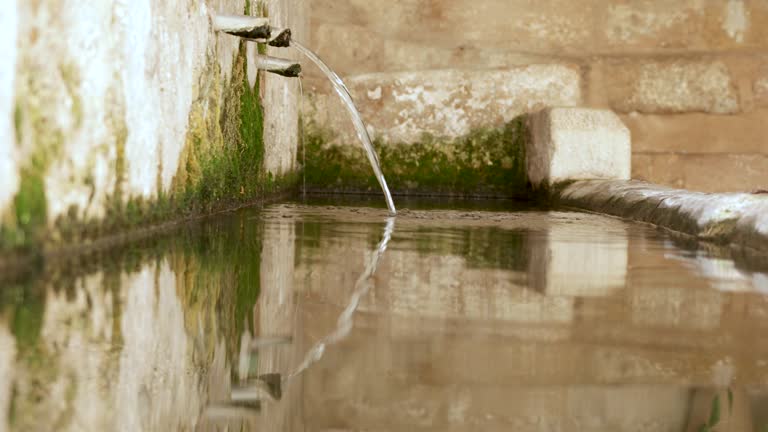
[0,0,307,253]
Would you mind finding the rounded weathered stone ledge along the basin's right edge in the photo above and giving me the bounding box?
[553,180,768,252]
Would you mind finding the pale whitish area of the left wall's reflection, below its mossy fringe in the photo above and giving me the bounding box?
[4,261,213,431]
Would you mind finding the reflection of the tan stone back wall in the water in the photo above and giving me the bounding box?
[282,208,768,431]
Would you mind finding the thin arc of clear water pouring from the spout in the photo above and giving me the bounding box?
[291,40,397,216]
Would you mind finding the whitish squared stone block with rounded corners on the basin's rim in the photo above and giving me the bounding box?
[526,108,632,187]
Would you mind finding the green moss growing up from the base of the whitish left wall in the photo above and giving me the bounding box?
[0,38,298,253]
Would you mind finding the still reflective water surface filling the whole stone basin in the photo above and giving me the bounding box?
[0,200,768,431]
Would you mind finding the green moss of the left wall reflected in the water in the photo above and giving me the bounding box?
[0,202,263,430]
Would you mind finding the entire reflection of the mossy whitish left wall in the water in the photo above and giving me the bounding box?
[0,208,270,431]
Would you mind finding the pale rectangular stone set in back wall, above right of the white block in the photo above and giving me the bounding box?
[598,60,740,114]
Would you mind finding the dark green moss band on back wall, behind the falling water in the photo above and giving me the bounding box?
[303,116,529,196]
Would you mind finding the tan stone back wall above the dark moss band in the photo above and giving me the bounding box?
[307,0,768,191]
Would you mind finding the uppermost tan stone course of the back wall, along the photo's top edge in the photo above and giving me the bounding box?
[311,0,768,61]
